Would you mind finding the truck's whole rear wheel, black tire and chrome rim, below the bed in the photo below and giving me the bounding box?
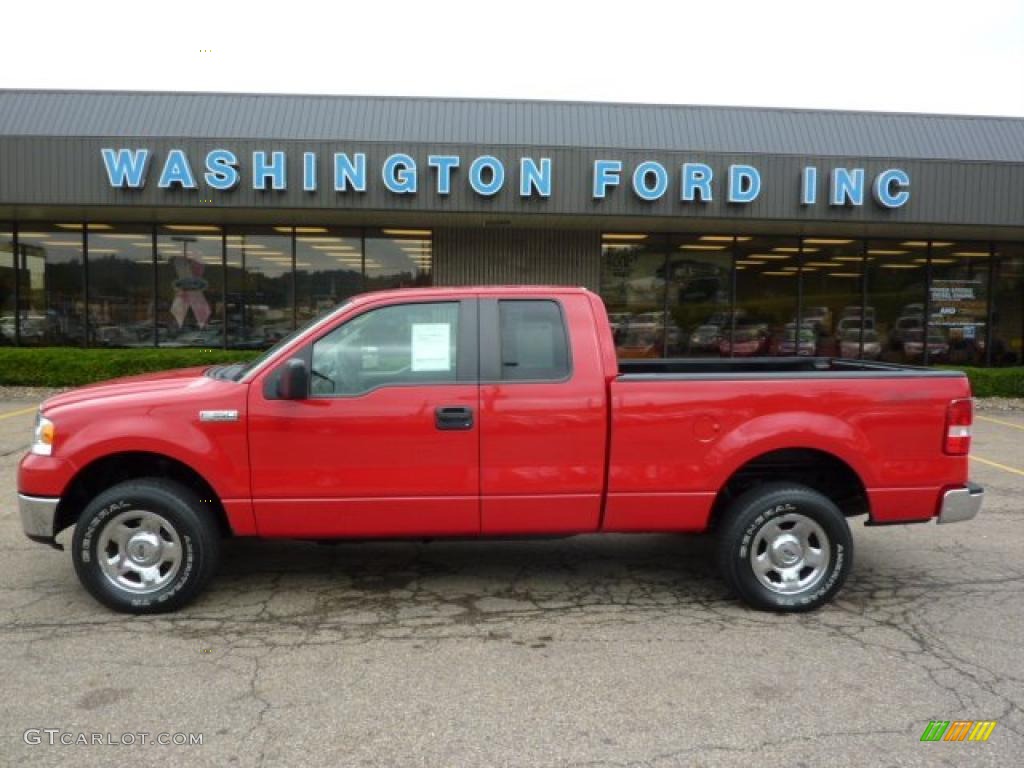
[718,482,853,612]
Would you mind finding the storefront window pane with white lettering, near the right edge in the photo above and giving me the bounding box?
[928,241,989,366]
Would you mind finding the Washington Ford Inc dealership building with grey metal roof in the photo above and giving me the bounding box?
[0,90,1024,366]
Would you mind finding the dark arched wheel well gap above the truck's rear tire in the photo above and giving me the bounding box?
[711,449,870,528]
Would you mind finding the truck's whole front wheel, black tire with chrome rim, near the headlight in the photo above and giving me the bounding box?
[72,478,220,613]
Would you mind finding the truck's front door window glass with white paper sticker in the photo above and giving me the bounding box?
[309,301,459,397]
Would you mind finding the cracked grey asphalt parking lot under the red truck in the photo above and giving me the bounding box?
[0,401,1024,768]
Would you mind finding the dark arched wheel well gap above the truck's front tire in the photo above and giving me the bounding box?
[53,452,231,536]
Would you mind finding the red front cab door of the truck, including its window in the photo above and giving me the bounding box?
[249,298,480,538]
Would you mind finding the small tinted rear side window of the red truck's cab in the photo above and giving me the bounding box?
[498,300,569,381]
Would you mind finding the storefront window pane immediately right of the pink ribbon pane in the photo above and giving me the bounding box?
[226,227,288,349]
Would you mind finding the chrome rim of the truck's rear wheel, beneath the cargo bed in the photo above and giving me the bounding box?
[750,512,831,595]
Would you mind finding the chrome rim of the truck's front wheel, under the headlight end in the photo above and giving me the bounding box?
[96,509,181,595]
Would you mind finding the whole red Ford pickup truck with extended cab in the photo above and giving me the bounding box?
[18,287,983,613]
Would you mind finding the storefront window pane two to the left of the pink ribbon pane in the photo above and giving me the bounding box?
[18,224,85,346]
